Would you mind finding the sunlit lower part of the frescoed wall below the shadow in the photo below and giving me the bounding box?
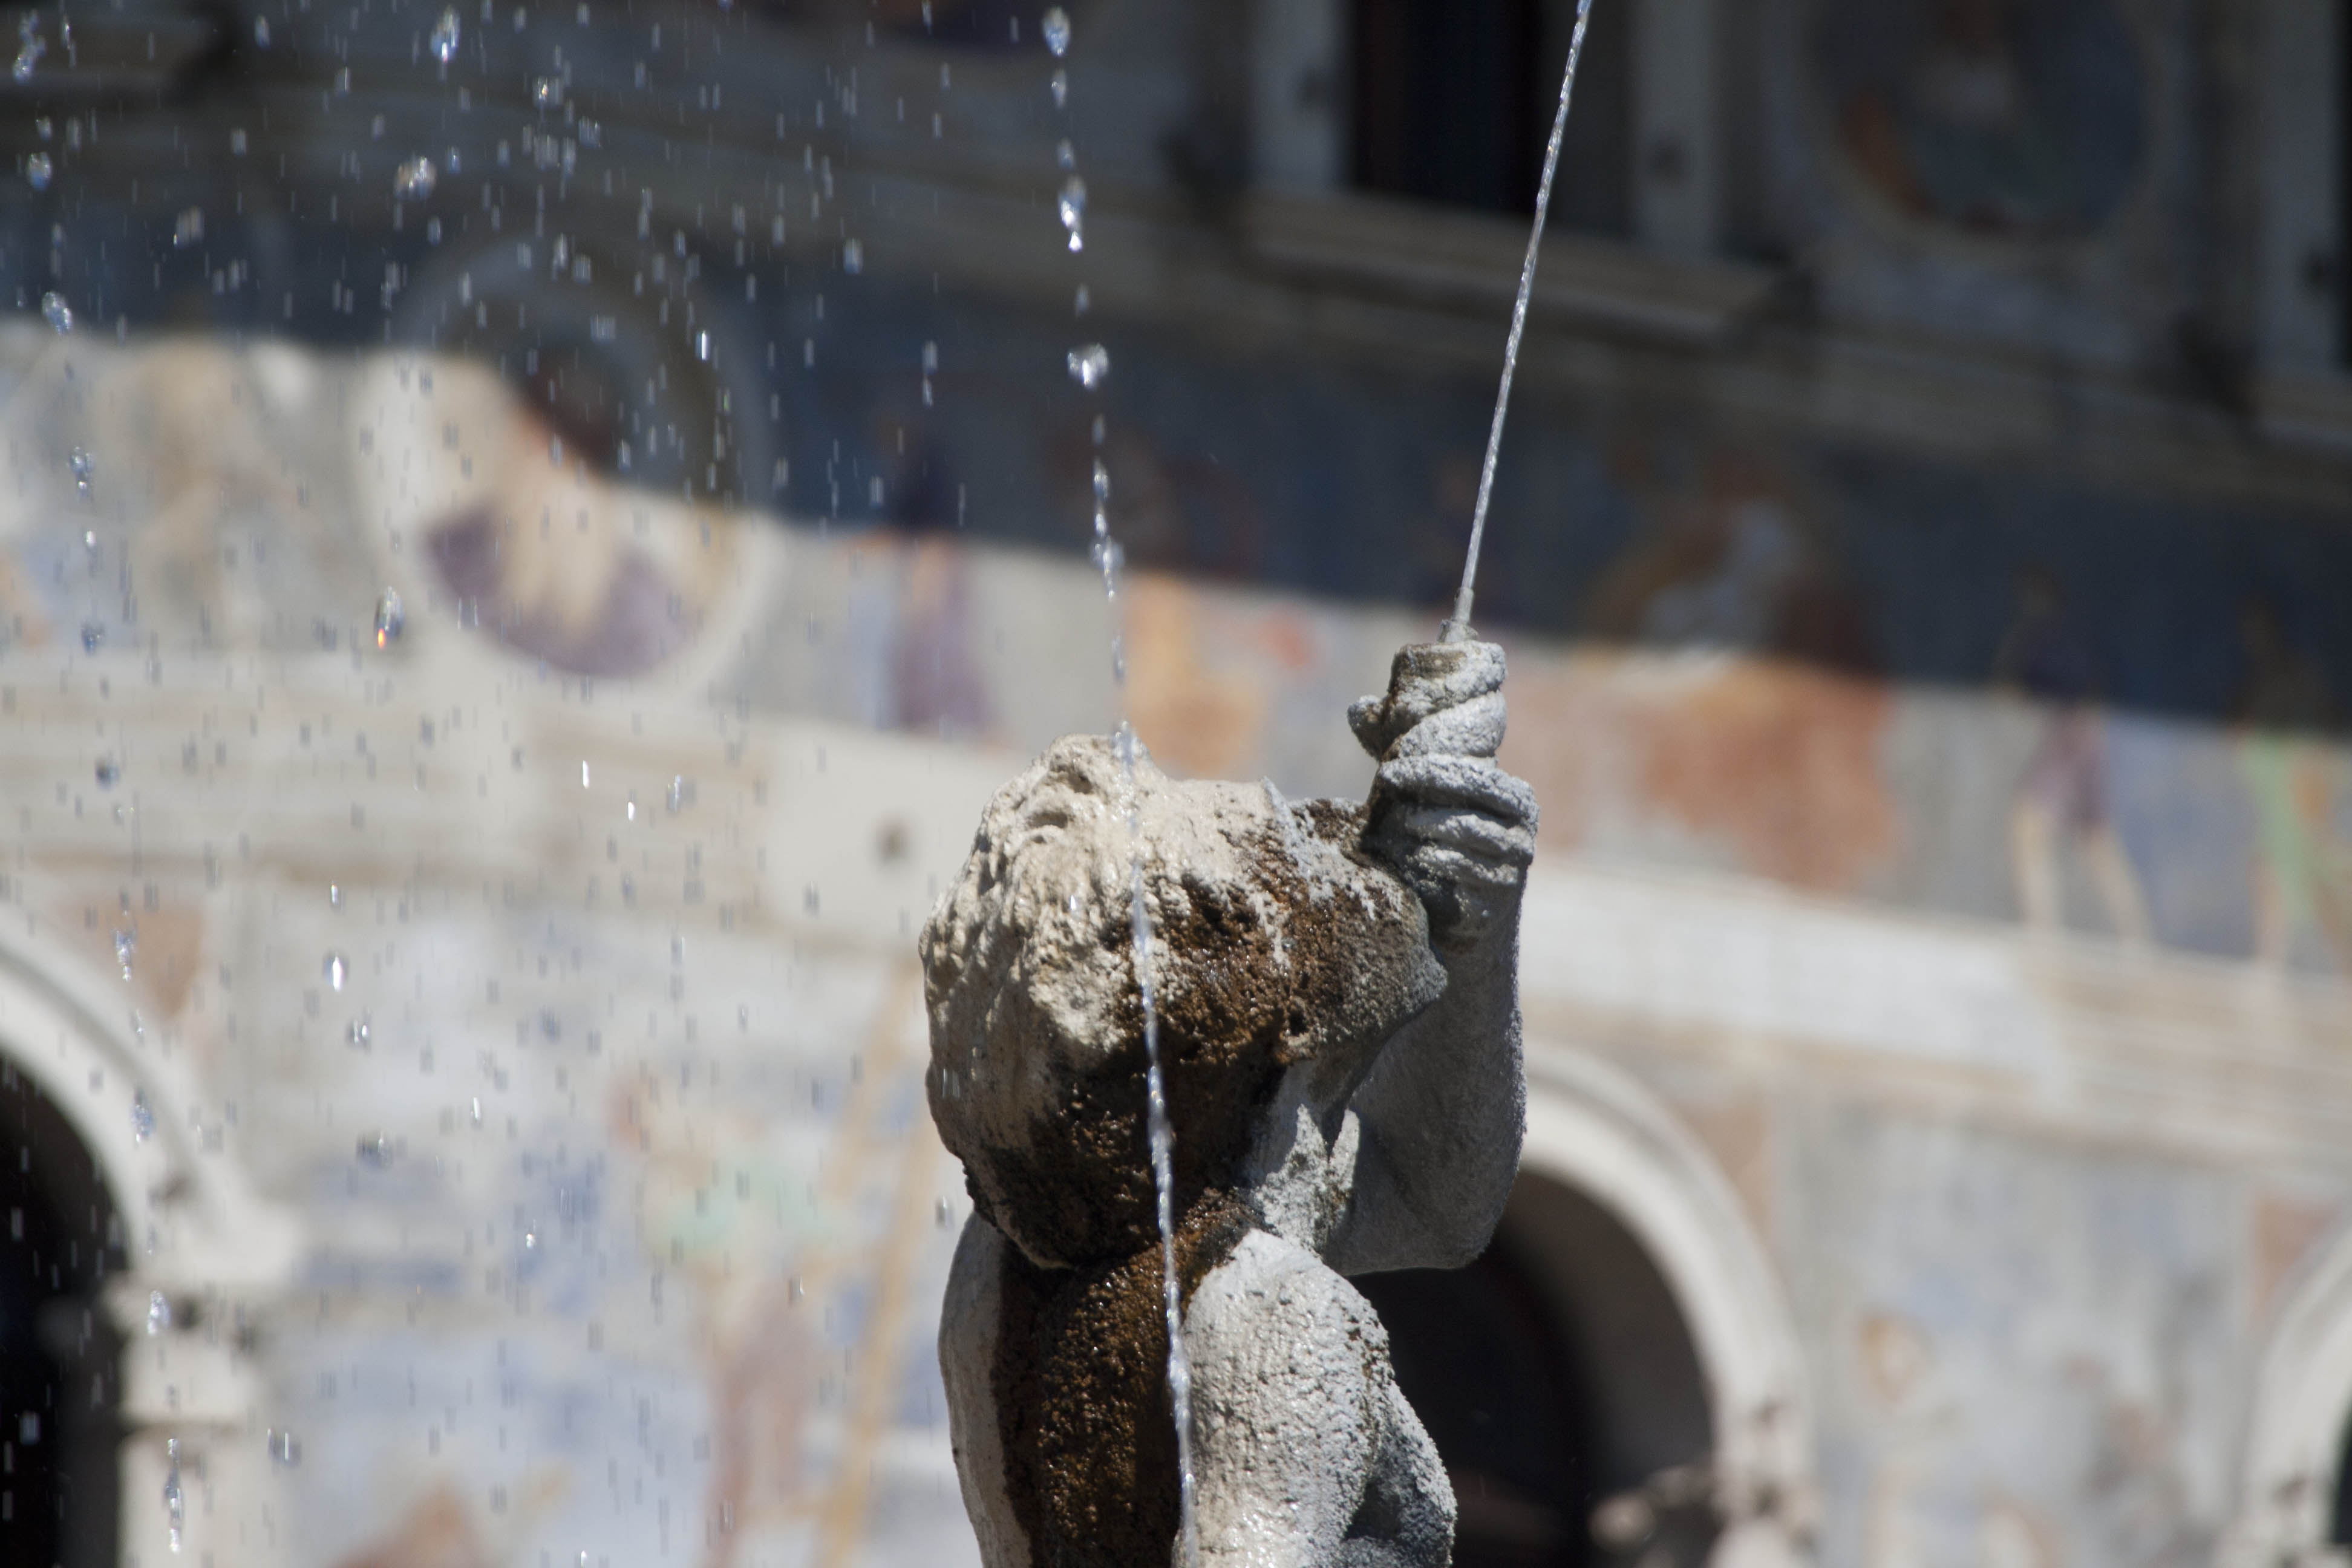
[0,334,2352,1568]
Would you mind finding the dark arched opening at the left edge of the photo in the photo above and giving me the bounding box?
[0,1058,122,1568]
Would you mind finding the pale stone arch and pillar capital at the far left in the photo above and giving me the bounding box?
[0,936,299,1566]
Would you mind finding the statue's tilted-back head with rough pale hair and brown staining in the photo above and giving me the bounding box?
[922,736,1444,1267]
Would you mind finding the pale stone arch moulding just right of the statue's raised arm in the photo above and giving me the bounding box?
[1520,1046,1816,1568]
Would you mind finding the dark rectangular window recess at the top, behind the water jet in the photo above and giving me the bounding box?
[1354,0,1630,235]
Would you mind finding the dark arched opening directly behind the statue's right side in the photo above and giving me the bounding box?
[1354,1173,1717,1568]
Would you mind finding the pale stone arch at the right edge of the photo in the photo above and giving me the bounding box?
[2220,1225,2352,1568]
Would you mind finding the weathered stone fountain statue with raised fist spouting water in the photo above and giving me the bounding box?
[922,642,1536,1568]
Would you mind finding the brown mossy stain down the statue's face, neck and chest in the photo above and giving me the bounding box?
[967,802,1423,1568]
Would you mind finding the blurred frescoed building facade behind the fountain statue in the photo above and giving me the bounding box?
[0,0,2352,1568]
